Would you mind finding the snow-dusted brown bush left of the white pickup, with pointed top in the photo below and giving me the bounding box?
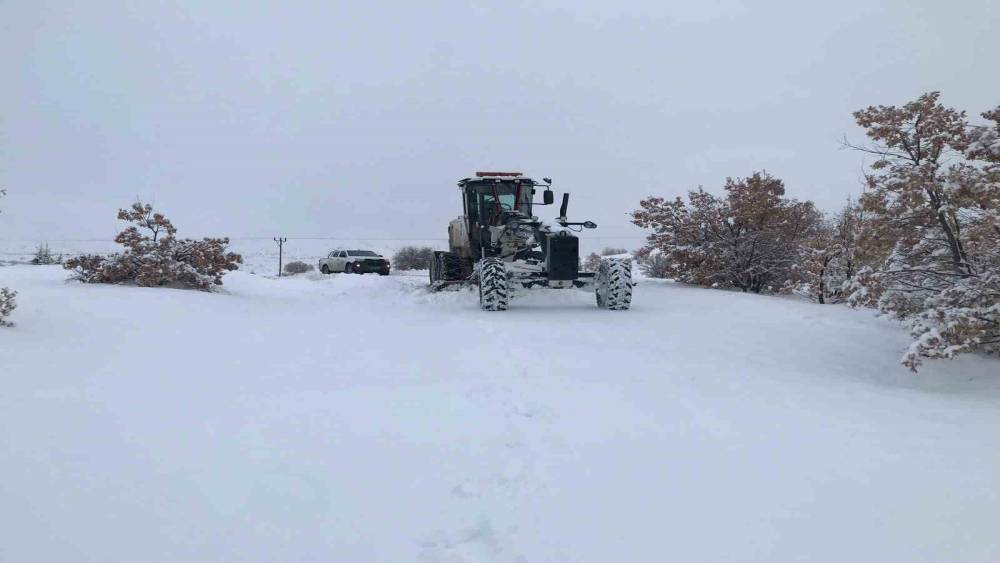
[63,203,242,290]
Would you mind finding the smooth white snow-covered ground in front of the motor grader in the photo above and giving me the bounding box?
[0,266,1000,563]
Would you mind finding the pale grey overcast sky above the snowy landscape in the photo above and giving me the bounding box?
[0,0,1000,239]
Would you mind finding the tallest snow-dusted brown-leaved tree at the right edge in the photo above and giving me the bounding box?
[850,92,1000,370]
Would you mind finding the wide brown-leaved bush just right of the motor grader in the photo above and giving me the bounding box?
[632,172,821,293]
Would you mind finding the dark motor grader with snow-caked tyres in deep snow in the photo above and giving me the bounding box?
[430,172,632,311]
